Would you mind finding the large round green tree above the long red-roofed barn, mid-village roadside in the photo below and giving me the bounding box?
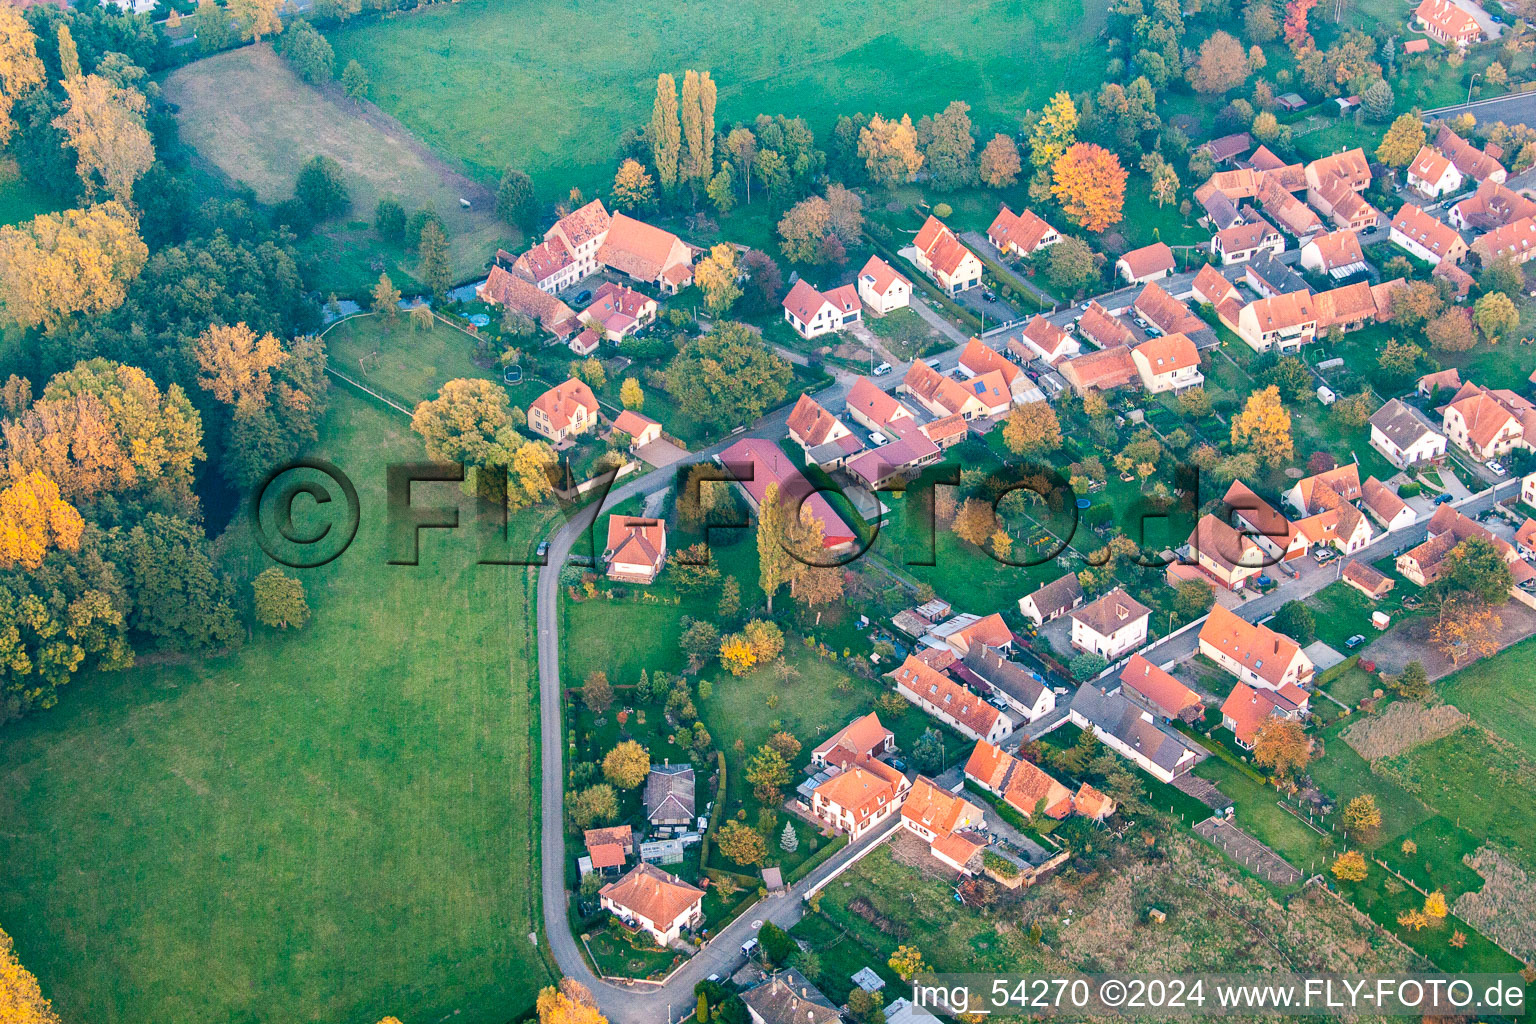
[667,321,791,425]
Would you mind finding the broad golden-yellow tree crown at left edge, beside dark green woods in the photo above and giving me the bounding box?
[0,201,149,333]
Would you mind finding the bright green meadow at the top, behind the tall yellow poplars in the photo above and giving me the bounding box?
[330,0,1106,198]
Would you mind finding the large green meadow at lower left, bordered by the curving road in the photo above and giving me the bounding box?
[0,393,547,1024]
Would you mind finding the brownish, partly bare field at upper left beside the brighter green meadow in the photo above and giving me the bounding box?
[164,46,516,295]
